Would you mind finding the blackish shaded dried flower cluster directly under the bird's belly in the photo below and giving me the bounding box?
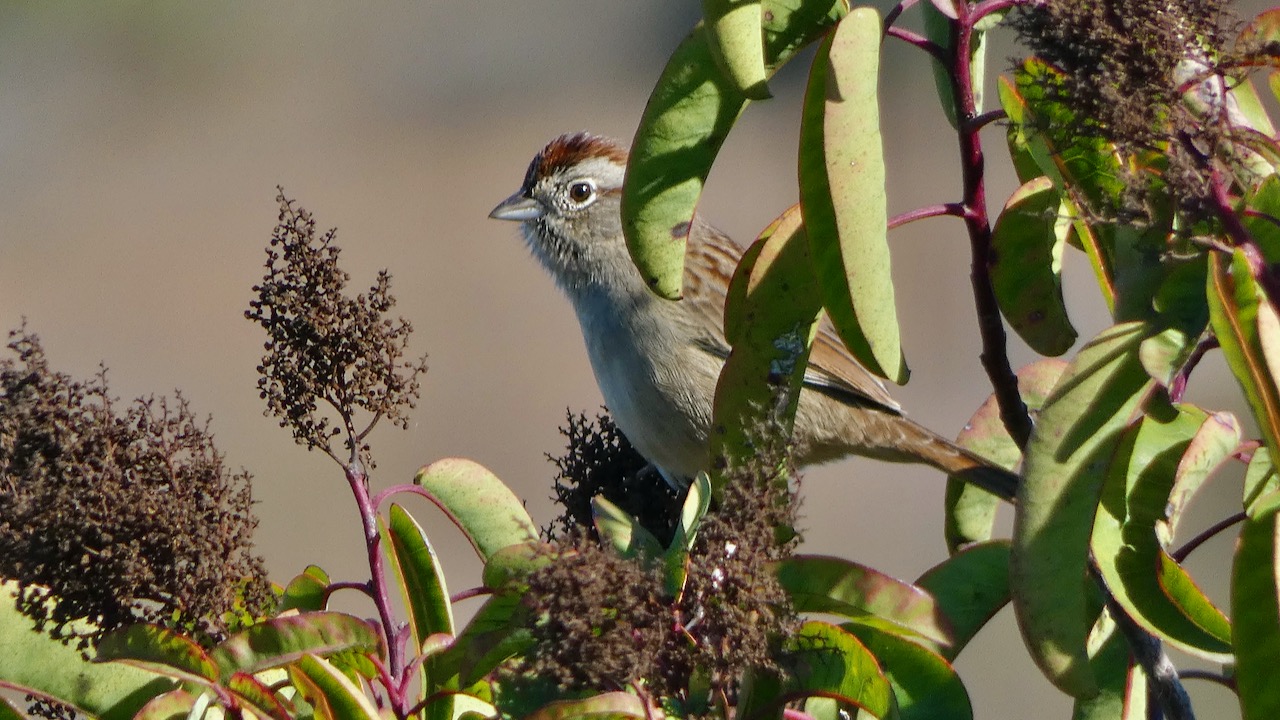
[544,413,682,543]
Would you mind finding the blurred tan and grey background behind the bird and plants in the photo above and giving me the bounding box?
[0,0,1262,717]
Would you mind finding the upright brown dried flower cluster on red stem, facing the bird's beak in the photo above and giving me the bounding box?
[244,190,426,466]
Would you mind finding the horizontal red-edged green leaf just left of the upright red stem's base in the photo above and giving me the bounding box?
[210,611,383,679]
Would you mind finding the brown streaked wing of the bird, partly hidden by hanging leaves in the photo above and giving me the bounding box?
[681,217,901,413]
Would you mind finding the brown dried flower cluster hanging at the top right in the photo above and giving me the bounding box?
[1011,0,1242,219]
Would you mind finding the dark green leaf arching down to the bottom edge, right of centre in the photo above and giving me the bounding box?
[841,623,973,720]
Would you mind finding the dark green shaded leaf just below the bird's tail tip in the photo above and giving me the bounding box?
[915,541,1009,660]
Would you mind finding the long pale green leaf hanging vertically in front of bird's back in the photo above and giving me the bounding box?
[800,8,910,384]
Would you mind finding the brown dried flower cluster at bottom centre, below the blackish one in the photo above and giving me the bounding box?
[511,418,797,702]
